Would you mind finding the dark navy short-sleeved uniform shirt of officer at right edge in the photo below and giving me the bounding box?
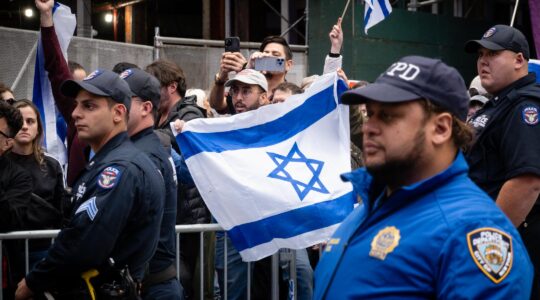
[467,73,540,199]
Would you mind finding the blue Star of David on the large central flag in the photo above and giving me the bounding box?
[268,143,329,200]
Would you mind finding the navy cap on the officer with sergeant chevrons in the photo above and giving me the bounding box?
[60,70,133,110]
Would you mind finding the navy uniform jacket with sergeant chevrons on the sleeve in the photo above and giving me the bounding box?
[26,132,165,292]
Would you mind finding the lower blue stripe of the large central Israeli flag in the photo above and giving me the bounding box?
[227,192,355,251]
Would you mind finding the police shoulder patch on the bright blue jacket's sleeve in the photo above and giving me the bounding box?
[467,227,514,283]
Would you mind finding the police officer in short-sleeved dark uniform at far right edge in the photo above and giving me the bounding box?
[465,25,540,299]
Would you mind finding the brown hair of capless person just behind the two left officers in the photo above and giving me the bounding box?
[145,59,186,98]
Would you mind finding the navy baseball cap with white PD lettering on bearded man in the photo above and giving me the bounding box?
[341,56,469,121]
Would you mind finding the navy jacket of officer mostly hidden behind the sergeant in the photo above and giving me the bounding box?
[131,127,177,274]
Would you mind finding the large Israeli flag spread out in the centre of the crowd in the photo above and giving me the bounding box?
[176,72,355,261]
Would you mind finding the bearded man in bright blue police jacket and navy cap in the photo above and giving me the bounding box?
[315,56,533,299]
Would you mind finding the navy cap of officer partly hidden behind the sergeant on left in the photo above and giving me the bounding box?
[120,68,161,107]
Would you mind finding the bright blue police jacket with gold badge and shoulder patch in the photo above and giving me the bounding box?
[315,153,533,299]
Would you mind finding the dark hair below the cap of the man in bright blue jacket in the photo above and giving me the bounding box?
[420,99,474,151]
